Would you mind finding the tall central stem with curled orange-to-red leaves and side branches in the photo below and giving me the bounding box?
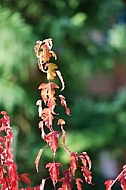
[34,38,92,190]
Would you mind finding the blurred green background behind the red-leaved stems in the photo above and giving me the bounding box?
[0,0,126,190]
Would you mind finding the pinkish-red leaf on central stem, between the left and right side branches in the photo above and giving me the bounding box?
[44,131,60,156]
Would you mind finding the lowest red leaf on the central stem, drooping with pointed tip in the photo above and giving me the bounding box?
[46,162,62,187]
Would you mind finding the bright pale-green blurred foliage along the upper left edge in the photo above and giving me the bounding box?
[0,7,34,113]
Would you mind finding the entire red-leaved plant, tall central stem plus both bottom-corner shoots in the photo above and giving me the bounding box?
[0,38,126,190]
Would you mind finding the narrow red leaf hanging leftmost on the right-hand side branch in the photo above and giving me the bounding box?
[70,152,78,176]
